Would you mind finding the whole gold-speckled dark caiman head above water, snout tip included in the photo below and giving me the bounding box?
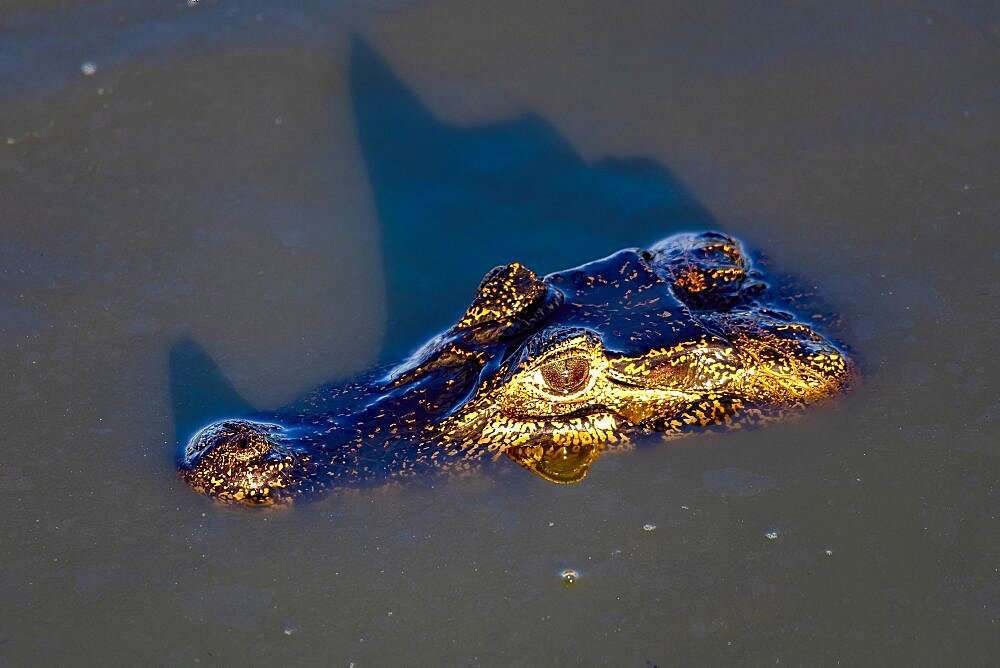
[180,232,850,504]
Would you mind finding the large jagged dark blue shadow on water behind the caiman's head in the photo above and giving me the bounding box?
[350,37,717,358]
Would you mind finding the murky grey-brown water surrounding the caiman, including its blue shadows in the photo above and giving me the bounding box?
[0,0,1000,666]
